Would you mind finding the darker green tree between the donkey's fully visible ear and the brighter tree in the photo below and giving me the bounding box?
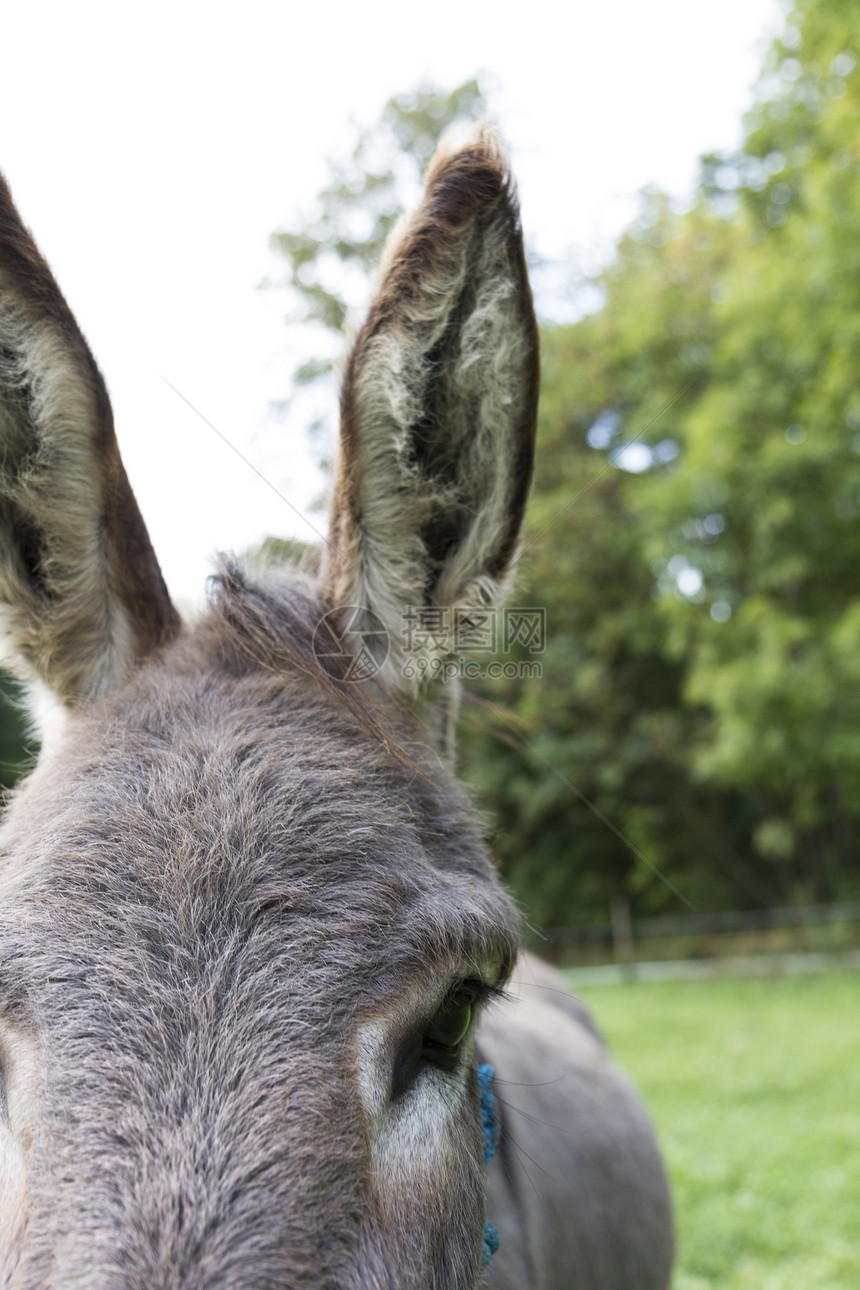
[464,232,775,925]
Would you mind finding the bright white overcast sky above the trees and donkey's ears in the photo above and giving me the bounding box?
[0,0,781,605]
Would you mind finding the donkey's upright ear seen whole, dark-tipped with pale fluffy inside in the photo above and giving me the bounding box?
[322,125,538,688]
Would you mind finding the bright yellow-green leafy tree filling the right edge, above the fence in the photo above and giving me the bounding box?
[649,0,860,899]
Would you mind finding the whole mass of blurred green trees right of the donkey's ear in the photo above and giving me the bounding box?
[467,0,860,924]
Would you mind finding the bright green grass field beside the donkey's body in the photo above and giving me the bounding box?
[576,973,860,1290]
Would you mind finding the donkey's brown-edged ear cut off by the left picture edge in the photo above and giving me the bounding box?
[0,177,179,703]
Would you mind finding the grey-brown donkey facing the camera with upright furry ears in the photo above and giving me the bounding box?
[0,126,672,1290]
